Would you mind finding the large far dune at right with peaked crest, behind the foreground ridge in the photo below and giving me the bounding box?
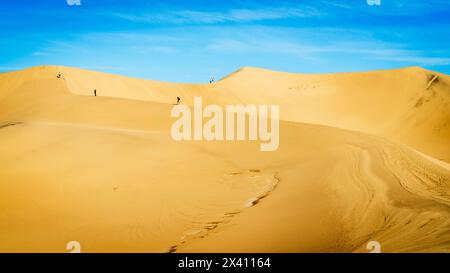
[218,67,450,162]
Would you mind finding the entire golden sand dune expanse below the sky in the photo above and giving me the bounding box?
[0,66,450,252]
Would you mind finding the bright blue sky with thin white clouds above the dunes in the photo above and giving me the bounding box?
[0,0,450,83]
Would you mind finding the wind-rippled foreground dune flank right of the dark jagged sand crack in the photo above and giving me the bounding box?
[179,126,450,252]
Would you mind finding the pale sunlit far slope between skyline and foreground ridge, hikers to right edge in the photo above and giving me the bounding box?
[50,67,450,162]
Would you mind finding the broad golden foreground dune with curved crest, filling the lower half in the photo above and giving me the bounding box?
[0,120,450,252]
